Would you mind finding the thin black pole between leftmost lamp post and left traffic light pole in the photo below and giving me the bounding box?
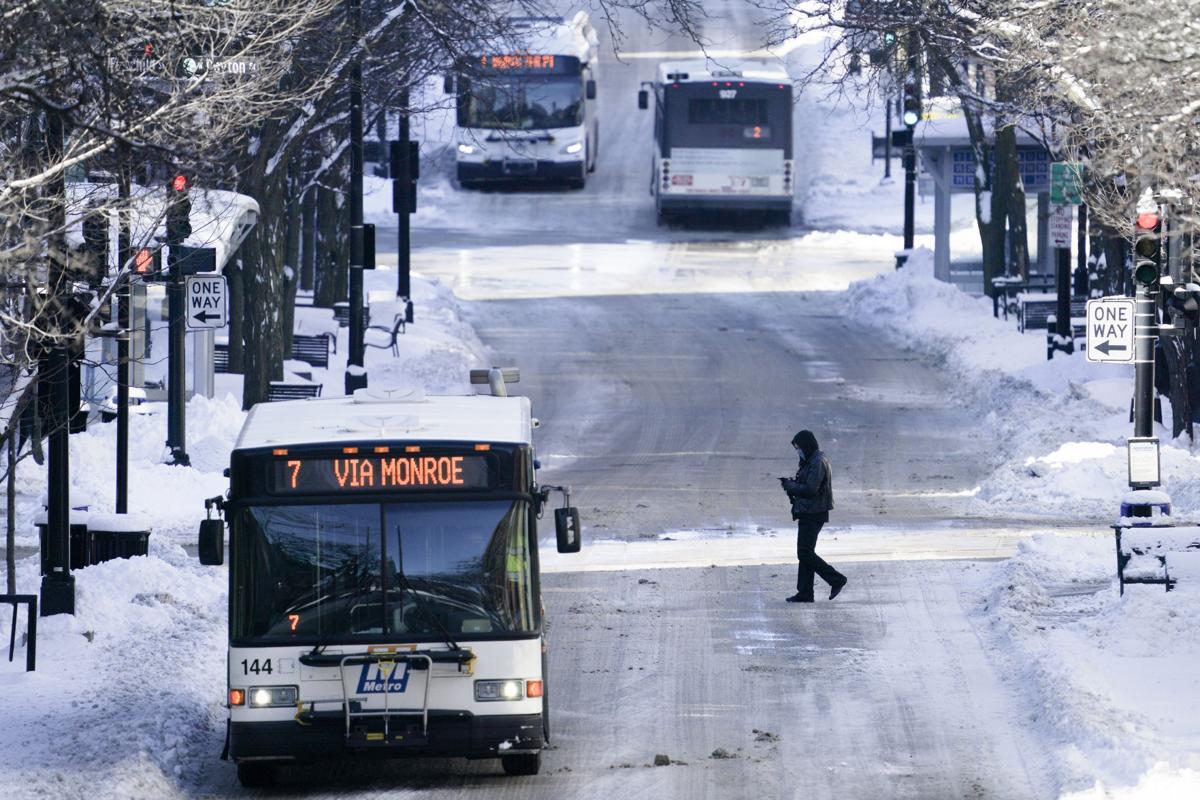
[115,144,133,513]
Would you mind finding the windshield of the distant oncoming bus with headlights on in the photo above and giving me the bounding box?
[458,76,583,131]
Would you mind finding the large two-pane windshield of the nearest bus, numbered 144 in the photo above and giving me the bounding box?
[232,500,538,643]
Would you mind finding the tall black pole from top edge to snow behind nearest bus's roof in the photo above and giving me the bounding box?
[346,0,367,395]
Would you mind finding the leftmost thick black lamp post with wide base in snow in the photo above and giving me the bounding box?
[38,112,74,616]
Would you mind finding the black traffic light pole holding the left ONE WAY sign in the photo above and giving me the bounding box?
[167,174,192,467]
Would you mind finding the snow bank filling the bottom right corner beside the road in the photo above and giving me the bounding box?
[977,534,1200,800]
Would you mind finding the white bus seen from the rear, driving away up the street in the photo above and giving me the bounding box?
[637,60,794,223]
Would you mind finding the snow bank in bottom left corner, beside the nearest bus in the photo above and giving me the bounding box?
[0,546,228,800]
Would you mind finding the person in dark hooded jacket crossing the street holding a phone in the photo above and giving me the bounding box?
[779,431,846,603]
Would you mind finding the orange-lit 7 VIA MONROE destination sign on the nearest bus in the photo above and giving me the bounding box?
[271,455,490,494]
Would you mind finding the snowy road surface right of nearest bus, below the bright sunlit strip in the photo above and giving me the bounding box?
[184,561,1052,800]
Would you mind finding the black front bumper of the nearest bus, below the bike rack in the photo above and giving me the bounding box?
[229,711,544,762]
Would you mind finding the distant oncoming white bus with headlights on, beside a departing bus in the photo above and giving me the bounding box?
[448,11,600,188]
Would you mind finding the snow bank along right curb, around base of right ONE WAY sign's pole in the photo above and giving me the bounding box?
[846,248,1200,523]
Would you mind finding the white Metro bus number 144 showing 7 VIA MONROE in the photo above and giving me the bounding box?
[199,369,580,786]
